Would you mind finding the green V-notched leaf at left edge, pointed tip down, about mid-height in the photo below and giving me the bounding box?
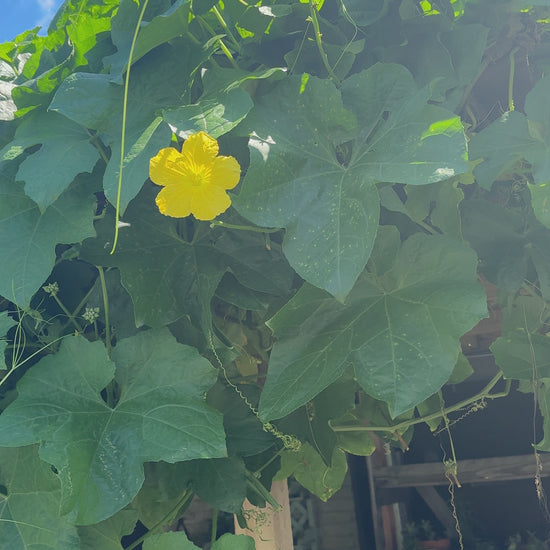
[0,175,96,309]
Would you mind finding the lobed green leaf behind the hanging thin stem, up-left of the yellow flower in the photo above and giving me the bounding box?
[50,40,208,212]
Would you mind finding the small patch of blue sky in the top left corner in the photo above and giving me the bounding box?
[0,0,63,43]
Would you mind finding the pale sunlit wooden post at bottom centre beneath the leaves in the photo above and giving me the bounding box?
[235,480,294,550]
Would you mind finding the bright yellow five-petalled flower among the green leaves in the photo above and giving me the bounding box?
[149,132,241,220]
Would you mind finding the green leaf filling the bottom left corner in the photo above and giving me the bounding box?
[0,447,80,550]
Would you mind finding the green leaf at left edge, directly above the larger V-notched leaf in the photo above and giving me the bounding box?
[0,112,99,212]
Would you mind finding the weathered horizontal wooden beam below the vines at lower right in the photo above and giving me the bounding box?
[372,453,550,489]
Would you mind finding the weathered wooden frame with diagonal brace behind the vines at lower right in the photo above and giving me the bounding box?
[366,281,550,550]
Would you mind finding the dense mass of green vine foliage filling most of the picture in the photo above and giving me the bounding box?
[0,0,550,550]
